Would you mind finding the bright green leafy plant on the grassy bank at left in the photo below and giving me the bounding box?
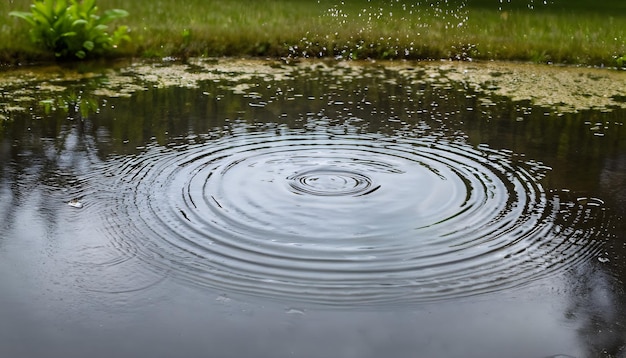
[9,0,130,59]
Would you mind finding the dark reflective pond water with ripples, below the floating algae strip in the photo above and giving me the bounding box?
[0,60,626,357]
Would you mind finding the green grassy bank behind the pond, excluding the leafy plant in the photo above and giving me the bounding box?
[0,0,626,66]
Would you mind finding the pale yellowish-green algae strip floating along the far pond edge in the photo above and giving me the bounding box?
[0,58,626,120]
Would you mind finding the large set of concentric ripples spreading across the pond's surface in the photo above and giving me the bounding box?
[98,126,604,305]
